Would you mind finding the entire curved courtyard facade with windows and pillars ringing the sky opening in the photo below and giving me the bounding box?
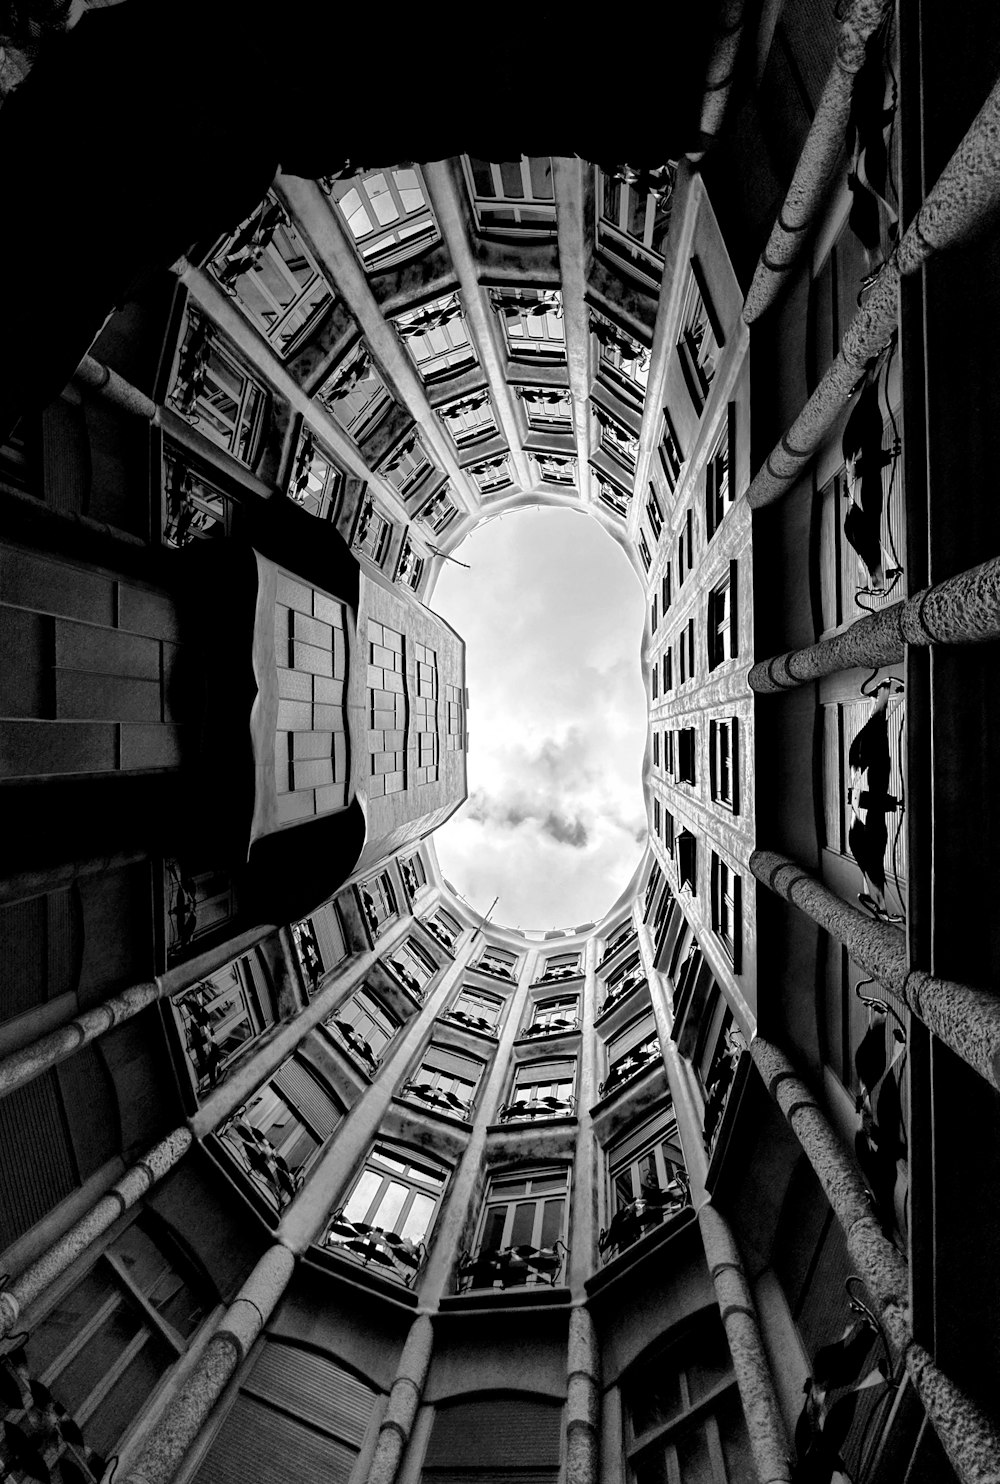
[0,0,1000,1484]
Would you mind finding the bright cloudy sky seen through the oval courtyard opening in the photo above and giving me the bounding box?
[430,508,647,929]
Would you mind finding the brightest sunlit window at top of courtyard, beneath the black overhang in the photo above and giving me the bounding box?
[325,165,438,270]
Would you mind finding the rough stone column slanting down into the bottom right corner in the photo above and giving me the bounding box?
[751,1037,1000,1484]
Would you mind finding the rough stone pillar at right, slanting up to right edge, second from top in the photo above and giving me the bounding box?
[746,69,1000,509]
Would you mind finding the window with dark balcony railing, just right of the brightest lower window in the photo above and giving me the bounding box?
[458,1169,570,1288]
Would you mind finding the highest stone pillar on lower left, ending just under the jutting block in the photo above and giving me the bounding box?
[0,928,273,1097]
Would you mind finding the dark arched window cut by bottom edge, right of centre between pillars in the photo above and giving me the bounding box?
[622,1310,757,1484]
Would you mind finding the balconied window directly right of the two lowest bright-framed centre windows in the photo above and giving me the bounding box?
[598,1107,687,1261]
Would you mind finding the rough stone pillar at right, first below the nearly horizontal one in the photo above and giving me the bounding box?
[749,850,1000,1089]
